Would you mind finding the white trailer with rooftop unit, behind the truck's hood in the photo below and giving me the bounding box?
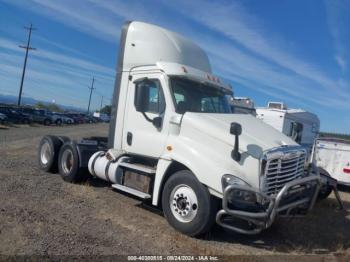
[256,102,320,153]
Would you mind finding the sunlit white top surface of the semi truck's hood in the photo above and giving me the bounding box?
[181,113,298,158]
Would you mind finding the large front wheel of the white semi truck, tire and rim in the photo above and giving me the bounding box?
[162,170,217,237]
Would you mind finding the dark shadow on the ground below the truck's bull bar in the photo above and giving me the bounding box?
[205,198,350,253]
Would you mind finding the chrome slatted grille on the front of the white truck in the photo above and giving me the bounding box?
[262,148,306,195]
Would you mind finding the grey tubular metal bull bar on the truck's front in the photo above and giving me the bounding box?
[216,175,321,235]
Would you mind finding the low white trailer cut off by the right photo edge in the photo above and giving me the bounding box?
[315,138,350,186]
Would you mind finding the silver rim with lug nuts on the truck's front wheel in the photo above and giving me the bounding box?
[169,185,198,223]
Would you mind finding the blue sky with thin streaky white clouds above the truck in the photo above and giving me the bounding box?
[0,0,350,133]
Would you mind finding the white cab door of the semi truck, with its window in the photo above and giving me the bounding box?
[122,73,169,158]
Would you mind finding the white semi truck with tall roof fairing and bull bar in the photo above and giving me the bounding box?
[38,22,321,236]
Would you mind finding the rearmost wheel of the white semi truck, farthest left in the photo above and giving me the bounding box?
[38,136,63,173]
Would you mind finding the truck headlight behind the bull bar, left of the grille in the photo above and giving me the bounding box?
[221,174,257,203]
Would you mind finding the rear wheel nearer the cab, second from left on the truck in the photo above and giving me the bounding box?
[58,141,88,183]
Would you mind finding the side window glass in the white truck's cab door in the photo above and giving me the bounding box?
[135,79,165,114]
